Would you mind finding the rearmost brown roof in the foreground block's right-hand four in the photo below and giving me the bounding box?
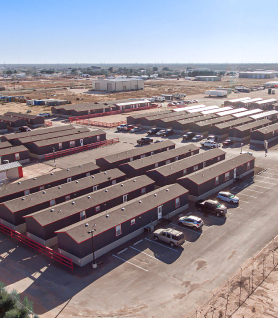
[99,140,175,163]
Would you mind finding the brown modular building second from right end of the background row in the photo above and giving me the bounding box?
[229,119,271,142]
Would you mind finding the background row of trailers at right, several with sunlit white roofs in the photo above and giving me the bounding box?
[127,105,278,142]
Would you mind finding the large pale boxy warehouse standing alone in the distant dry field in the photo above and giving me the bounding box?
[92,78,144,92]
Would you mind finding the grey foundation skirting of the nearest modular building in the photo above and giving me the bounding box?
[58,204,188,267]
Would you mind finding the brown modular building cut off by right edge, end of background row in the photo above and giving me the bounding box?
[250,123,278,147]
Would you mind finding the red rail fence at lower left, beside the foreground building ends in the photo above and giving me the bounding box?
[0,224,73,270]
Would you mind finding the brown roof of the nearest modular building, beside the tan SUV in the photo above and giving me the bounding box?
[56,184,188,243]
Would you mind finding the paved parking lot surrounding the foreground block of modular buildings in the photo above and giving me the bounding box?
[0,120,278,318]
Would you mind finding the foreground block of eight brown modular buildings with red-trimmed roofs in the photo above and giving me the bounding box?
[0,140,255,266]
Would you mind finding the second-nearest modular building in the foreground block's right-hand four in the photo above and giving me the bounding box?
[146,148,226,186]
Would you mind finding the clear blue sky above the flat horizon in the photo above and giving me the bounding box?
[0,0,278,64]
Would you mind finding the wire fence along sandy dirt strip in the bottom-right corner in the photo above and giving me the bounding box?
[189,235,278,318]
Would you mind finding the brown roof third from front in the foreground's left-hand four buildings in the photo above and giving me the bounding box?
[5,169,126,213]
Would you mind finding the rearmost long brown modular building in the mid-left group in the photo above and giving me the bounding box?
[1,125,76,146]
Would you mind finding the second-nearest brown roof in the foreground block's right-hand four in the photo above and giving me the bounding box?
[150,148,225,177]
